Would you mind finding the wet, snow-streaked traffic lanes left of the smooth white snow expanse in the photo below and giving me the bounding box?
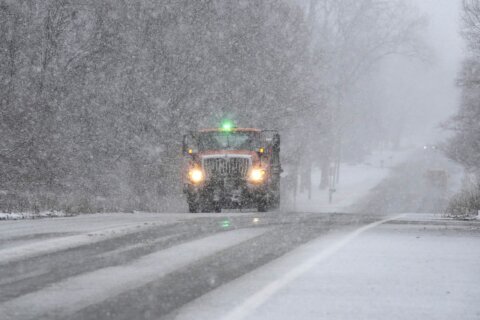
[0,212,379,319]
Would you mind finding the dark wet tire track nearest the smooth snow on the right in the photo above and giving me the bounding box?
[72,213,379,320]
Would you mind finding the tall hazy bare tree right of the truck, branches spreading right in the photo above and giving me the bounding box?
[296,0,426,187]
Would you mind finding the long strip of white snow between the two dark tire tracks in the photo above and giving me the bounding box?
[0,228,269,320]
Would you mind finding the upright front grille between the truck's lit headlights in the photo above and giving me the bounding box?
[203,157,251,178]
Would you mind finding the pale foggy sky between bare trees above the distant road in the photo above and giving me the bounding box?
[372,0,463,144]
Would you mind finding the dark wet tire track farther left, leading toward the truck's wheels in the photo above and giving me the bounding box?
[0,219,234,302]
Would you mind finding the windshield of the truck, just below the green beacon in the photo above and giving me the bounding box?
[198,131,260,151]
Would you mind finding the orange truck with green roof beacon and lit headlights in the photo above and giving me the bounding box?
[183,121,282,212]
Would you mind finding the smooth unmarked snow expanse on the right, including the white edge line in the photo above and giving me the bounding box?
[172,215,480,320]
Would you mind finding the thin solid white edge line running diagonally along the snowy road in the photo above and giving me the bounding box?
[221,214,404,320]
